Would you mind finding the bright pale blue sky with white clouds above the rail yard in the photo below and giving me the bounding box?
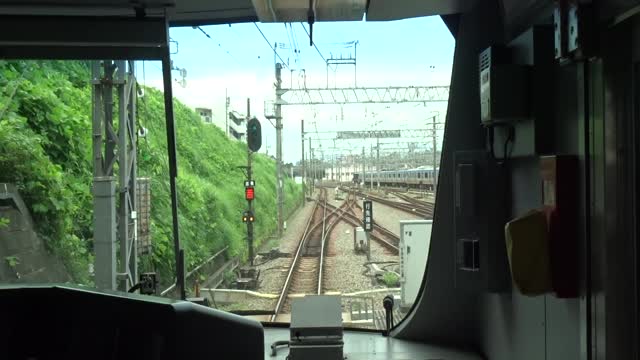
[142,17,455,163]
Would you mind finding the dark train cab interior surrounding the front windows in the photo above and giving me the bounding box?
[0,0,640,360]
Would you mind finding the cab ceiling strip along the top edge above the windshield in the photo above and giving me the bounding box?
[0,0,477,26]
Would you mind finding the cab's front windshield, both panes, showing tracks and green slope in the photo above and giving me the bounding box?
[0,17,454,329]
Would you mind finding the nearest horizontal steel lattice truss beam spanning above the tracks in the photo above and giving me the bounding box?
[276,86,449,105]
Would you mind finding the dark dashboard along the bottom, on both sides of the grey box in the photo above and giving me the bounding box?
[0,285,481,360]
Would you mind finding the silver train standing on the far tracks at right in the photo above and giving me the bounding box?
[352,167,439,189]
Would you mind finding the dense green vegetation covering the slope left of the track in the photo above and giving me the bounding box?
[0,61,301,284]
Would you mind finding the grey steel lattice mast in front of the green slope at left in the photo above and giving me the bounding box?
[92,60,138,291]
